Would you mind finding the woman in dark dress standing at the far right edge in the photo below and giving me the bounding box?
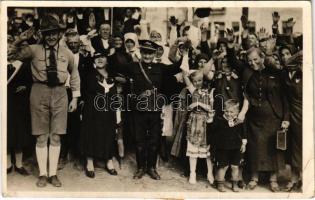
[279,47,303,192]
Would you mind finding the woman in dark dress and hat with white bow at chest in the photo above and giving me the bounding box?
[80,53,117,178]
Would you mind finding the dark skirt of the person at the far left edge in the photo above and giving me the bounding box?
[7,88,32,150]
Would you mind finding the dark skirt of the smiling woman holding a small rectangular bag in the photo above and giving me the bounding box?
[247,101,285,172]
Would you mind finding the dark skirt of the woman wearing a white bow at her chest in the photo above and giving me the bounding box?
[80,96,116,160]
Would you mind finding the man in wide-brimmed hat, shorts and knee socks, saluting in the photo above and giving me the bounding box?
[15,15,80,187]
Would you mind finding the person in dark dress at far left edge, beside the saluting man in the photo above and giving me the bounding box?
[7,61,32,176]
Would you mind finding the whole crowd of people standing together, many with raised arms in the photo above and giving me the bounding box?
[7,8,303,192]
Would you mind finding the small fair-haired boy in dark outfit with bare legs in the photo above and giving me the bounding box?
[207,99,247,192]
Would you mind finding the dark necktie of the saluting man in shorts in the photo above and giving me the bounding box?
[47,47,59,87]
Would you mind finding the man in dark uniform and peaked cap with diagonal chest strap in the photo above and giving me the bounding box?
[117,40,181,180]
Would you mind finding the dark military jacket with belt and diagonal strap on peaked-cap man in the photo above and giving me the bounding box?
[115,62,181,111]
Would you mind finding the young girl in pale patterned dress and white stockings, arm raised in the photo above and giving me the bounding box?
[184,71,214,184]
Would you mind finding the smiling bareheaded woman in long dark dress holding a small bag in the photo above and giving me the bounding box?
[243,48,289,192]
